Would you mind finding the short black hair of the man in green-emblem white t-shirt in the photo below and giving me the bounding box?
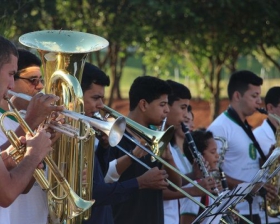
[227,70,263,100]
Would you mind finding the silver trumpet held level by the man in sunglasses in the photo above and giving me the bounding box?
[7,90,126,147]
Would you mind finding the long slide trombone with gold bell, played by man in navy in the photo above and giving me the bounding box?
[103,105,253,224]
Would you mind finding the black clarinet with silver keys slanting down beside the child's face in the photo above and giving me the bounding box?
[181,123,210,178]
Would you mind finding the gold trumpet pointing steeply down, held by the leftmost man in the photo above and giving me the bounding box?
[0,97,94,219]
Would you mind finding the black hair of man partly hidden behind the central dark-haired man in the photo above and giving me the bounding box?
[166,80,192,106]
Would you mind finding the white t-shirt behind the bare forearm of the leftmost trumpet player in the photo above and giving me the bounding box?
[0,111,49,224]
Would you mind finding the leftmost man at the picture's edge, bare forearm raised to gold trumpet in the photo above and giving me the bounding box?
[0,36,51,207]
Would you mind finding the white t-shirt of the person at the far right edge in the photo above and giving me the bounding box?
[253,120,280,223]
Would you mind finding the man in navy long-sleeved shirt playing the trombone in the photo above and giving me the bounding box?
[81,63,173,224]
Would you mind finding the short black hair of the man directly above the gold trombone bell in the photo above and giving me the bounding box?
[129,76,171,111]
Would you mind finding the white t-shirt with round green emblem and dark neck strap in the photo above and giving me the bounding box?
[208,112,259,215]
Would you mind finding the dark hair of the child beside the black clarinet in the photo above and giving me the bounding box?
[183,128,214,164]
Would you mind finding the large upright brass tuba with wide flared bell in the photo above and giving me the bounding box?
[19,30,109,223]
